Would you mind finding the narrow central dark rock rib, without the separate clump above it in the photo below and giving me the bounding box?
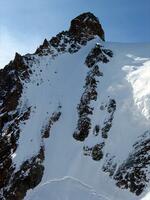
[73,66,100,141]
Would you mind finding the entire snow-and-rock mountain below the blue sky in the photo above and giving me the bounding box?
[0,13,150,200]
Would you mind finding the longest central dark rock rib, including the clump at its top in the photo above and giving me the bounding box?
[73,45,111,141]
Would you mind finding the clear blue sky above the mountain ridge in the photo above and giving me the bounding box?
[0,0,150,67]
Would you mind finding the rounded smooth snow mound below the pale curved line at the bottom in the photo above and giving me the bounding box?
[25,177,107,200]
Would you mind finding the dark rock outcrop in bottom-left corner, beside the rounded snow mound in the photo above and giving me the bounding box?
[2,147,44,200]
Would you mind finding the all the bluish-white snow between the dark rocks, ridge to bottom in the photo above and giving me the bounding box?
[13,39,150,200]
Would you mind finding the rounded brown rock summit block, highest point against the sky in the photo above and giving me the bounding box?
[69,12,105,40]
